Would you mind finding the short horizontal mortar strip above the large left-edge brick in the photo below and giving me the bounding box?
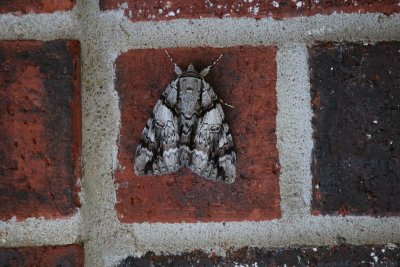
[0,11,80,41]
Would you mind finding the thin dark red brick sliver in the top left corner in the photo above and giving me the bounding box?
[0,0,75,14]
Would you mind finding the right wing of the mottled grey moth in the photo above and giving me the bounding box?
[189,84,236,183]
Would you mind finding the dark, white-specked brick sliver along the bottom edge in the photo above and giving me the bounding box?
[118,244,400,267]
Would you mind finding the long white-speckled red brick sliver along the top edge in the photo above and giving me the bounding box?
[100,0,400,21]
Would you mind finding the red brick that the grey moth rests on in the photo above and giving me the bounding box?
[115,46,280,223]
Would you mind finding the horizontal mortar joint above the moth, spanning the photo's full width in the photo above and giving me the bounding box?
[0,11,400,45]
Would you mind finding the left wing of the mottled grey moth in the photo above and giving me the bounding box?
[134,81,180,175]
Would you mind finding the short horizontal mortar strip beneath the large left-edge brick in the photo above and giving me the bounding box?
[0,211,81,247]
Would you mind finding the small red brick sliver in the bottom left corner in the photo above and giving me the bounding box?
[0,245,83,267]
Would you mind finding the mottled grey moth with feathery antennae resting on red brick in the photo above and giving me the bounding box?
[134,51,236,183]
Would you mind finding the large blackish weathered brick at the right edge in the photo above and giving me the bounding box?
[309,42,400,218]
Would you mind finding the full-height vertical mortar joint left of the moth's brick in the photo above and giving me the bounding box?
[74,0,141,266]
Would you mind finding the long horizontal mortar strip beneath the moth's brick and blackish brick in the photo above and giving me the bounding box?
[114,216,400,254]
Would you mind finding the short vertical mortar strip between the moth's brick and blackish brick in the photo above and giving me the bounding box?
[276,43,313,220]
